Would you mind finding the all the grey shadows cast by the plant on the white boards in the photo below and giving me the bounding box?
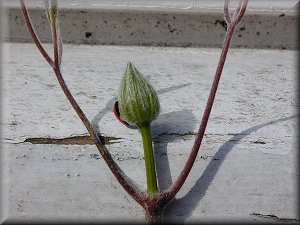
[91,78,297,224]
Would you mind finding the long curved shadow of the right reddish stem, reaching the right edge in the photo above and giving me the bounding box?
[164,115,297,224]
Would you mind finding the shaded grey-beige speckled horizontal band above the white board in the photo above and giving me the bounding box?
[5,7,297,49]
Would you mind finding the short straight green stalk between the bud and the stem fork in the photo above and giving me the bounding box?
[140,124,158,193]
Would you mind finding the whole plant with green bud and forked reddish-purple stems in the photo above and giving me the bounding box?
[19,0,248,223]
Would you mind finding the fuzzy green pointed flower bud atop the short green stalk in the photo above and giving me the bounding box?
[118,62,160,127]
